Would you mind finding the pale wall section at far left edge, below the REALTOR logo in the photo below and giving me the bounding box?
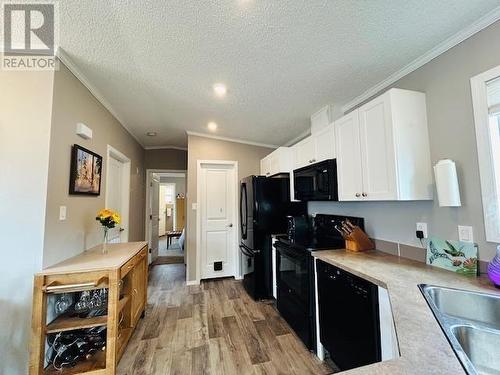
[0,69,54,375]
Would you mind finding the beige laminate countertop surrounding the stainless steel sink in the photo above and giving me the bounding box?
[313,250,500,375]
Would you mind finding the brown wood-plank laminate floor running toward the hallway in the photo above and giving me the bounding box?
[118,264,331,375]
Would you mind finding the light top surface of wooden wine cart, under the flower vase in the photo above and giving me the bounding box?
[38,241,148,275]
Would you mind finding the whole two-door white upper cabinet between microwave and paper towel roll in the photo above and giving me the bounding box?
[335,89,432,201]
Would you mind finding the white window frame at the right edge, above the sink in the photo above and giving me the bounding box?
[470,66,500,243]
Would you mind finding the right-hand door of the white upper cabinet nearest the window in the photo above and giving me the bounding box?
[358,94,398,201]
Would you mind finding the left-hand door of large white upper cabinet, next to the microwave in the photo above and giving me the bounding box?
[335,110,363,201]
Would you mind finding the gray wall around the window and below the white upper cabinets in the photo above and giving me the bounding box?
[309,22,500,261]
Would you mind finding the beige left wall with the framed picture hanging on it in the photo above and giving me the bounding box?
[43,63,145,267]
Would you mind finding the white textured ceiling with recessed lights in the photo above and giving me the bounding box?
[59,0,500,146]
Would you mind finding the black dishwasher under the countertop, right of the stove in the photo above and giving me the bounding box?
[316,259,381,371]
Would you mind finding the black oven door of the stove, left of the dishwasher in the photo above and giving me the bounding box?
[274,241,313,349]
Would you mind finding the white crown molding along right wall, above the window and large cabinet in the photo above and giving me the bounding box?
[342,7,500,113]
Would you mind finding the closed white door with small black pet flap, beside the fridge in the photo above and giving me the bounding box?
[198,164,237,279]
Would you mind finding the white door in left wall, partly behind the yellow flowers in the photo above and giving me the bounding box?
[106,157,126,243]
